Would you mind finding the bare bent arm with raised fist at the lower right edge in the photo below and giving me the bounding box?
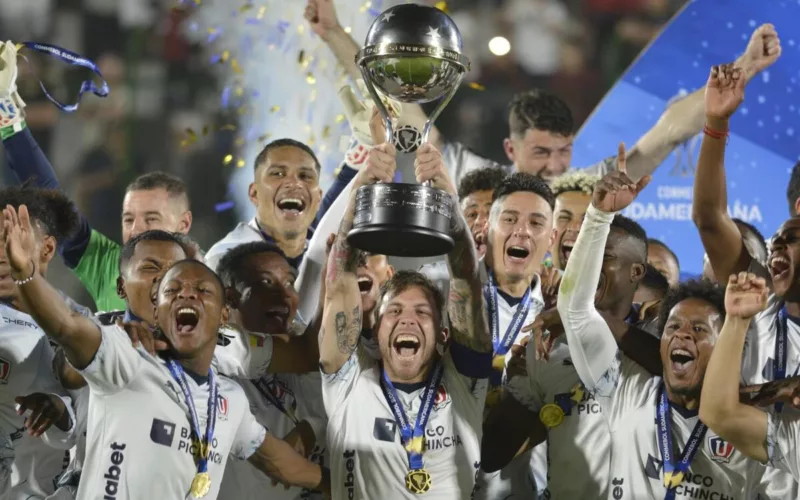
[700,272,769,463]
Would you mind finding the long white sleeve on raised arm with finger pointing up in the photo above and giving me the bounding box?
[558,204,620,396]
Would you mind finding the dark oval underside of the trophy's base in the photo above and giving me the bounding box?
[347,224,454,257]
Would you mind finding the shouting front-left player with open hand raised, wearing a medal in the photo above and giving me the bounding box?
[4,205,327,499]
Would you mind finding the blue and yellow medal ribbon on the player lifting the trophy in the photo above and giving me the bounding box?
[381,362,443,470]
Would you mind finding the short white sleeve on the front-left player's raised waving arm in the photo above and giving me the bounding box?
[79,325,145,394]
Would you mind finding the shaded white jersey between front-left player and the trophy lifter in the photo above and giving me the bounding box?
[219,373,326,500]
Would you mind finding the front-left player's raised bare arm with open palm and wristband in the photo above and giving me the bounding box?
[3,205,101,369]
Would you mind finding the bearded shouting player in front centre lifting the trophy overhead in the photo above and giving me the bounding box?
[320,135,492,499]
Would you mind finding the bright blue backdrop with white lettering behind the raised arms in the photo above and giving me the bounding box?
[573,0,800,275]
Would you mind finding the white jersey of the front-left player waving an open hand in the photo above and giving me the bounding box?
[78,325,266,500]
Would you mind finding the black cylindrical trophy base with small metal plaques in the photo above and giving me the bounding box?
[347,183,454,257]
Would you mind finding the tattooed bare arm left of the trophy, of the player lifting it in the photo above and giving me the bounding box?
[319,189,361,373]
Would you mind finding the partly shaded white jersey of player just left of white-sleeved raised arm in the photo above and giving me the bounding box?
[506,335,611,499]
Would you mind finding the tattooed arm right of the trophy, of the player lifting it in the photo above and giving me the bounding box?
[447,201,492,353]
